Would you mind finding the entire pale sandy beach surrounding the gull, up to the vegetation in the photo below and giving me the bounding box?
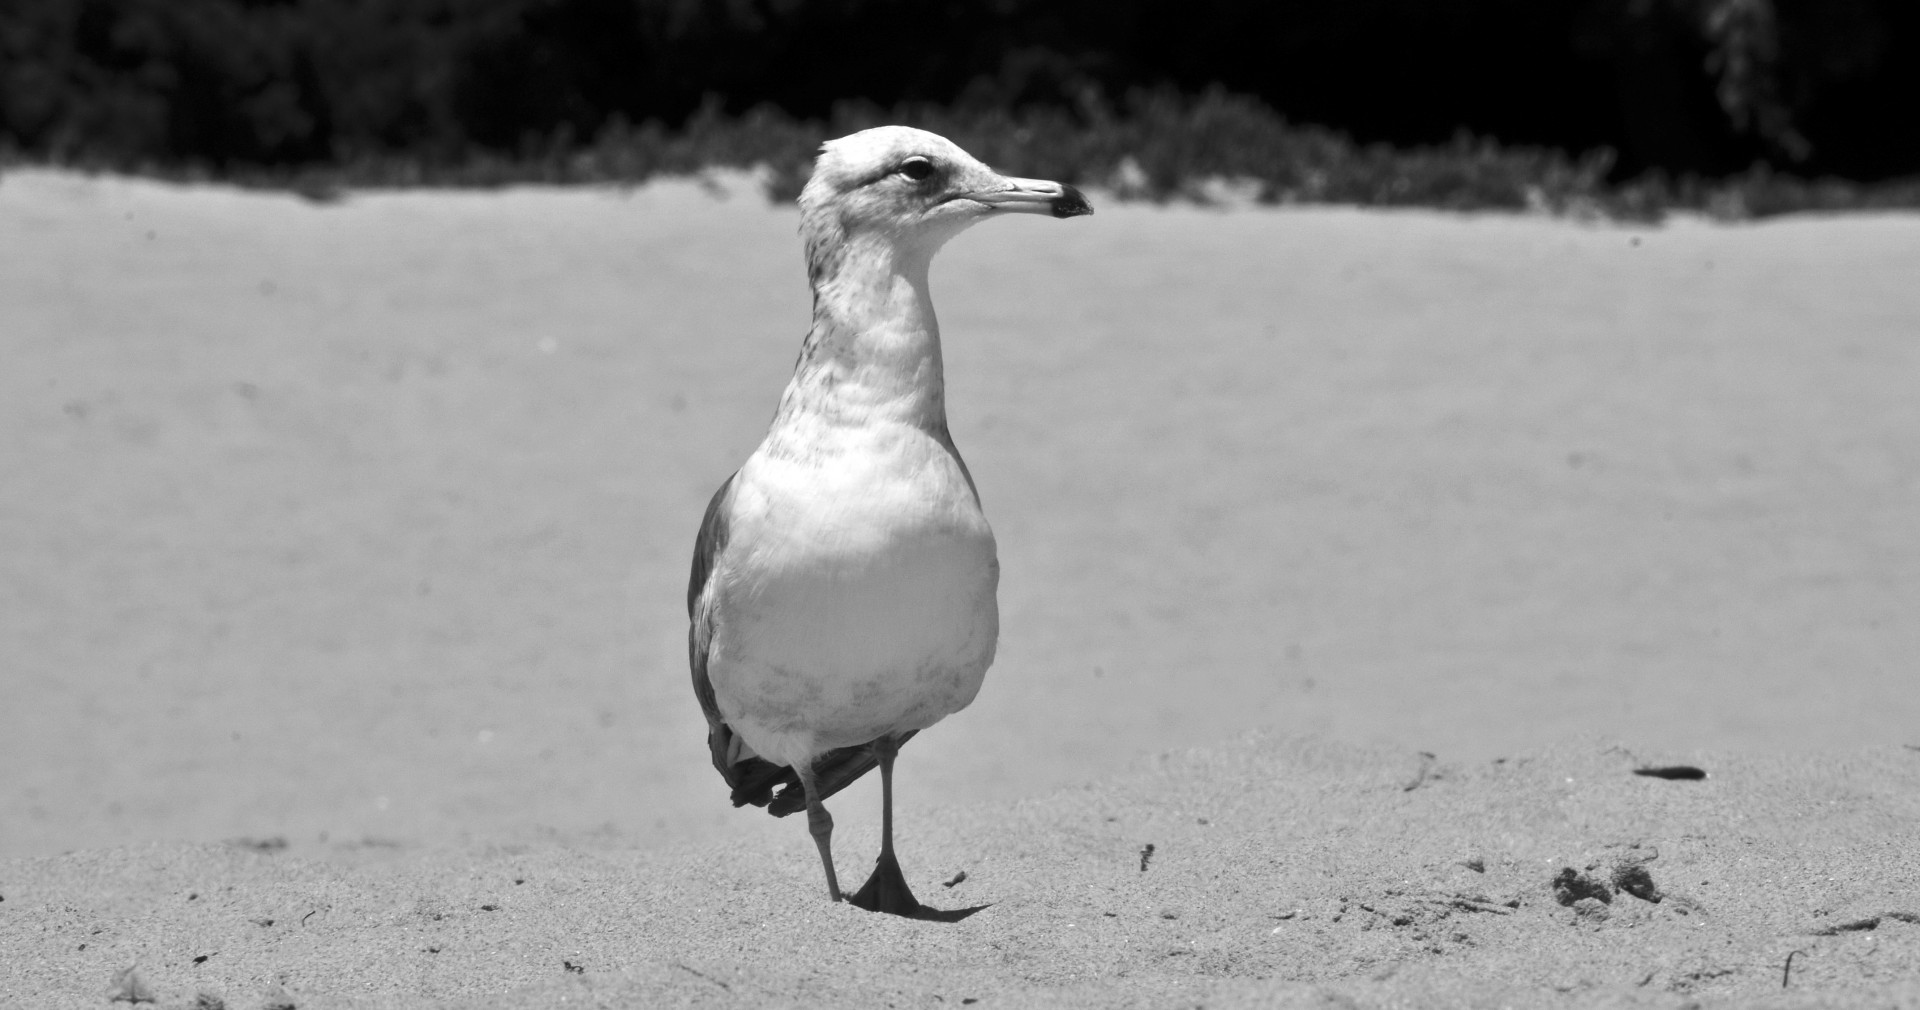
[0,171,1920,1006]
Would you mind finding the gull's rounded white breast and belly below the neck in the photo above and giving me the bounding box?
[708,424,1000,764]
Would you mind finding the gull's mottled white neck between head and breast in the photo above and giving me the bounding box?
[774,244,947,430]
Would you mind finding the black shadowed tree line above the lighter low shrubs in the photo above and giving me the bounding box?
[0,0,1920,180]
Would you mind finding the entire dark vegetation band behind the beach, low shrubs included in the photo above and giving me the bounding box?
[0,0,1920,215]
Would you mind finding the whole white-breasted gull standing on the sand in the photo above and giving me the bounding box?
[687,127,1092,920]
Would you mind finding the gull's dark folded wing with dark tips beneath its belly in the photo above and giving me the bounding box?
[687,472,918,818]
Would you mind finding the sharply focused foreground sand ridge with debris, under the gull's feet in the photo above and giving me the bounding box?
[0,737,1920,1008]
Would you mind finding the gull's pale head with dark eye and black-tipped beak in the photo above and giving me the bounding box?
[801,127,1092,282]
